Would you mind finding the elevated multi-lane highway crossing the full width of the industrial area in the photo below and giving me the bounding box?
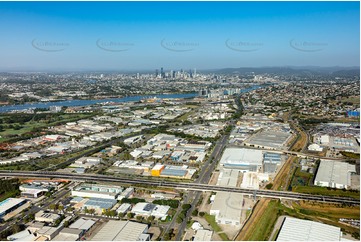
[0,171,360,205]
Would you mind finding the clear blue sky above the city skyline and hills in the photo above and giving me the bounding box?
[0,2,360,71]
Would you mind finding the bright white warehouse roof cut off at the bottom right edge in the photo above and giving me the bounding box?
[277,217,342,241]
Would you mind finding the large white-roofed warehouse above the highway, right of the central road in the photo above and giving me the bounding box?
[220,148,263,171]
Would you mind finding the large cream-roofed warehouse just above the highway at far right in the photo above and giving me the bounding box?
[314,160,356,189]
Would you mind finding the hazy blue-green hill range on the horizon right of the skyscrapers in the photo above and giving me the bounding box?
[212,66,360,76]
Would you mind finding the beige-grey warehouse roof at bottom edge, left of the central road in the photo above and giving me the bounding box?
[91,220,148,241]
